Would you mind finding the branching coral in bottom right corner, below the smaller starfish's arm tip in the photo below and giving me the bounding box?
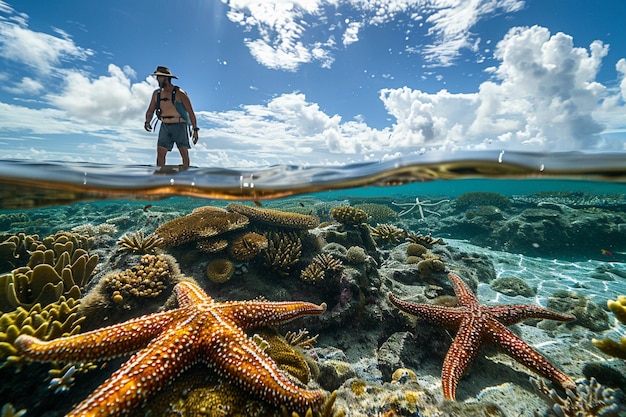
[530,377,626,417]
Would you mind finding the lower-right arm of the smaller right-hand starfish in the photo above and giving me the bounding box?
[482,321,576,392]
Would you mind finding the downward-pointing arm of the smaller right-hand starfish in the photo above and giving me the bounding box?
[441,316,481,400]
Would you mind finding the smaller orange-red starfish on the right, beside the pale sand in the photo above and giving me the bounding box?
[389,272,576,400]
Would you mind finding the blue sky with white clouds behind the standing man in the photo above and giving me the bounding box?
[0,0,626,167]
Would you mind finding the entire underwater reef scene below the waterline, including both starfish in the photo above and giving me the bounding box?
[0,154,626,417]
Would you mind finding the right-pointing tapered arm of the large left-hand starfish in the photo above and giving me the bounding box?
[215,301,326,329]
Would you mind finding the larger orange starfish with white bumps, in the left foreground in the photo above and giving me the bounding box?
[14,281,326,416]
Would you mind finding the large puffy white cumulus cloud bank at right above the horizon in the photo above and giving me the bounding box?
[381,26,619,150]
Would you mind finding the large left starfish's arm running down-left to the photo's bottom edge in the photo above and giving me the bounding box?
[67,327,197,417]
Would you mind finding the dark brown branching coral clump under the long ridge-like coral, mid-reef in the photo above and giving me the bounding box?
[263,232,302,277]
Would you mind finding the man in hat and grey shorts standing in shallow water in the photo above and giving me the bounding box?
[143,66,200,167]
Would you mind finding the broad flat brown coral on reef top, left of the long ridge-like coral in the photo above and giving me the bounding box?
[154,206,249,246]
